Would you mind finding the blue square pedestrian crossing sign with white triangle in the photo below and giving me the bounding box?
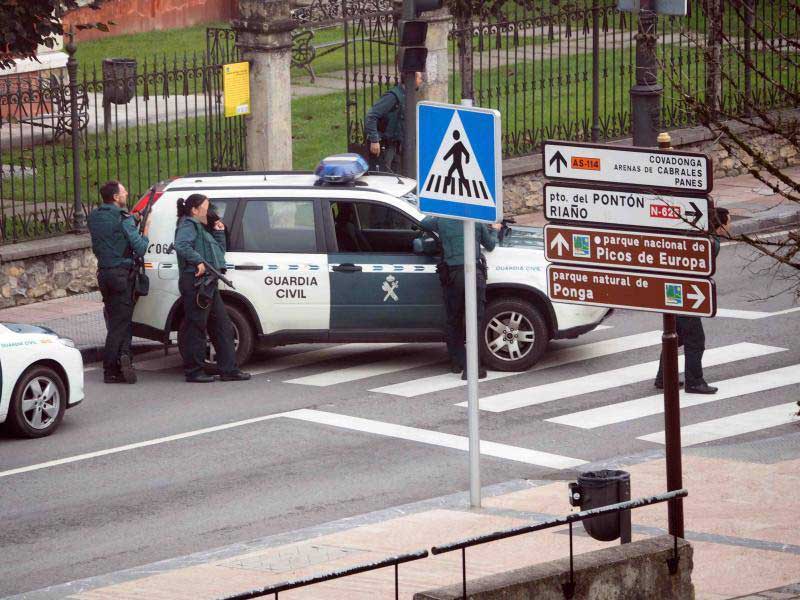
[417,102,503,223]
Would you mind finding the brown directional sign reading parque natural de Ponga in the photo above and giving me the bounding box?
[547,264,717,317]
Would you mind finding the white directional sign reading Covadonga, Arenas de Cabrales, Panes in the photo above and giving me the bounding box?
[542,141,713,194]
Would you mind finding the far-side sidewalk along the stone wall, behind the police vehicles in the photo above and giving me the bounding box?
[0,166,800,361]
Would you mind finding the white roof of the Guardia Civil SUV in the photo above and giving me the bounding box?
[164,171,417,197]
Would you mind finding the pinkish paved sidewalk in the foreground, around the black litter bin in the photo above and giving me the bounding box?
[15,433,800,600]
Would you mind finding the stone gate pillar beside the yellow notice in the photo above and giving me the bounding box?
[232,0,295,171]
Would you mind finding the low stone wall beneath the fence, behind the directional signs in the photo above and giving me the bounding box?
[503,111,800,216]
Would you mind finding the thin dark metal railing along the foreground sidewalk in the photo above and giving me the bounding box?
[220,489,689,600]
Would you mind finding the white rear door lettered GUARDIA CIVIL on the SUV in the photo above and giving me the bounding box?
[225,197,330,339]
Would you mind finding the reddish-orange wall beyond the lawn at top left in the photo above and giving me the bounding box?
[64,0,236,42]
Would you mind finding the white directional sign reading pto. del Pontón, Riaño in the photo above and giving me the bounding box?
[544,183,708,233]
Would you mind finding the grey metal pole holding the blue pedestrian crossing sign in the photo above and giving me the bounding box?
[461,99,481,508]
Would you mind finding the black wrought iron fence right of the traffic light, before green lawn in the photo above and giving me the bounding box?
[450,0,800,156]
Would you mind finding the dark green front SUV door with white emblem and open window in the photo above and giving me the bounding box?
[323,198,444,337]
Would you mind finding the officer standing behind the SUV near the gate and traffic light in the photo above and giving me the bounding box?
[364,72,422,173]
